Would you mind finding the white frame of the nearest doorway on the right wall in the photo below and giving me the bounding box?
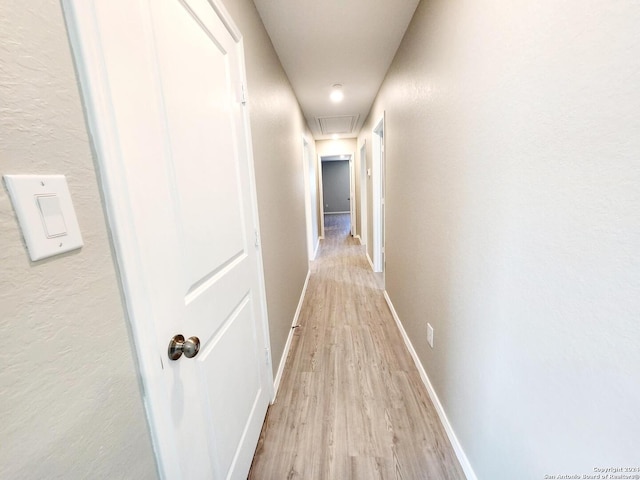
[371,112,385,273]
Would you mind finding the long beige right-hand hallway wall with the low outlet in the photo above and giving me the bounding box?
[359,0,640,480]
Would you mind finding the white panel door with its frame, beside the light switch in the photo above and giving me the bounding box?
[64,0,272,479]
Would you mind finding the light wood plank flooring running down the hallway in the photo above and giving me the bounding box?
[249,215,465,480]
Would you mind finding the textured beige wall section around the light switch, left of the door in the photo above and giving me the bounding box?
[0,0,156,480]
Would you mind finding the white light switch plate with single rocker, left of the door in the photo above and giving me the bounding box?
[4,175,83,261]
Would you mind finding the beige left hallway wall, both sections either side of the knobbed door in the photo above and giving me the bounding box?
[0,0,315,479]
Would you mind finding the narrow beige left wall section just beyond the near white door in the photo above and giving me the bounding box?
[224,0,316,374]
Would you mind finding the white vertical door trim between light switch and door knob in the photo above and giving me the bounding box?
[62,0,180,478]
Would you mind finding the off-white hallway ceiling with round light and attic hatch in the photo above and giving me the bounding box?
[254,0,419,140]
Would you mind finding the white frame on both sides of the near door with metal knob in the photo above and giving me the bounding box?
[62,0,274,478]
